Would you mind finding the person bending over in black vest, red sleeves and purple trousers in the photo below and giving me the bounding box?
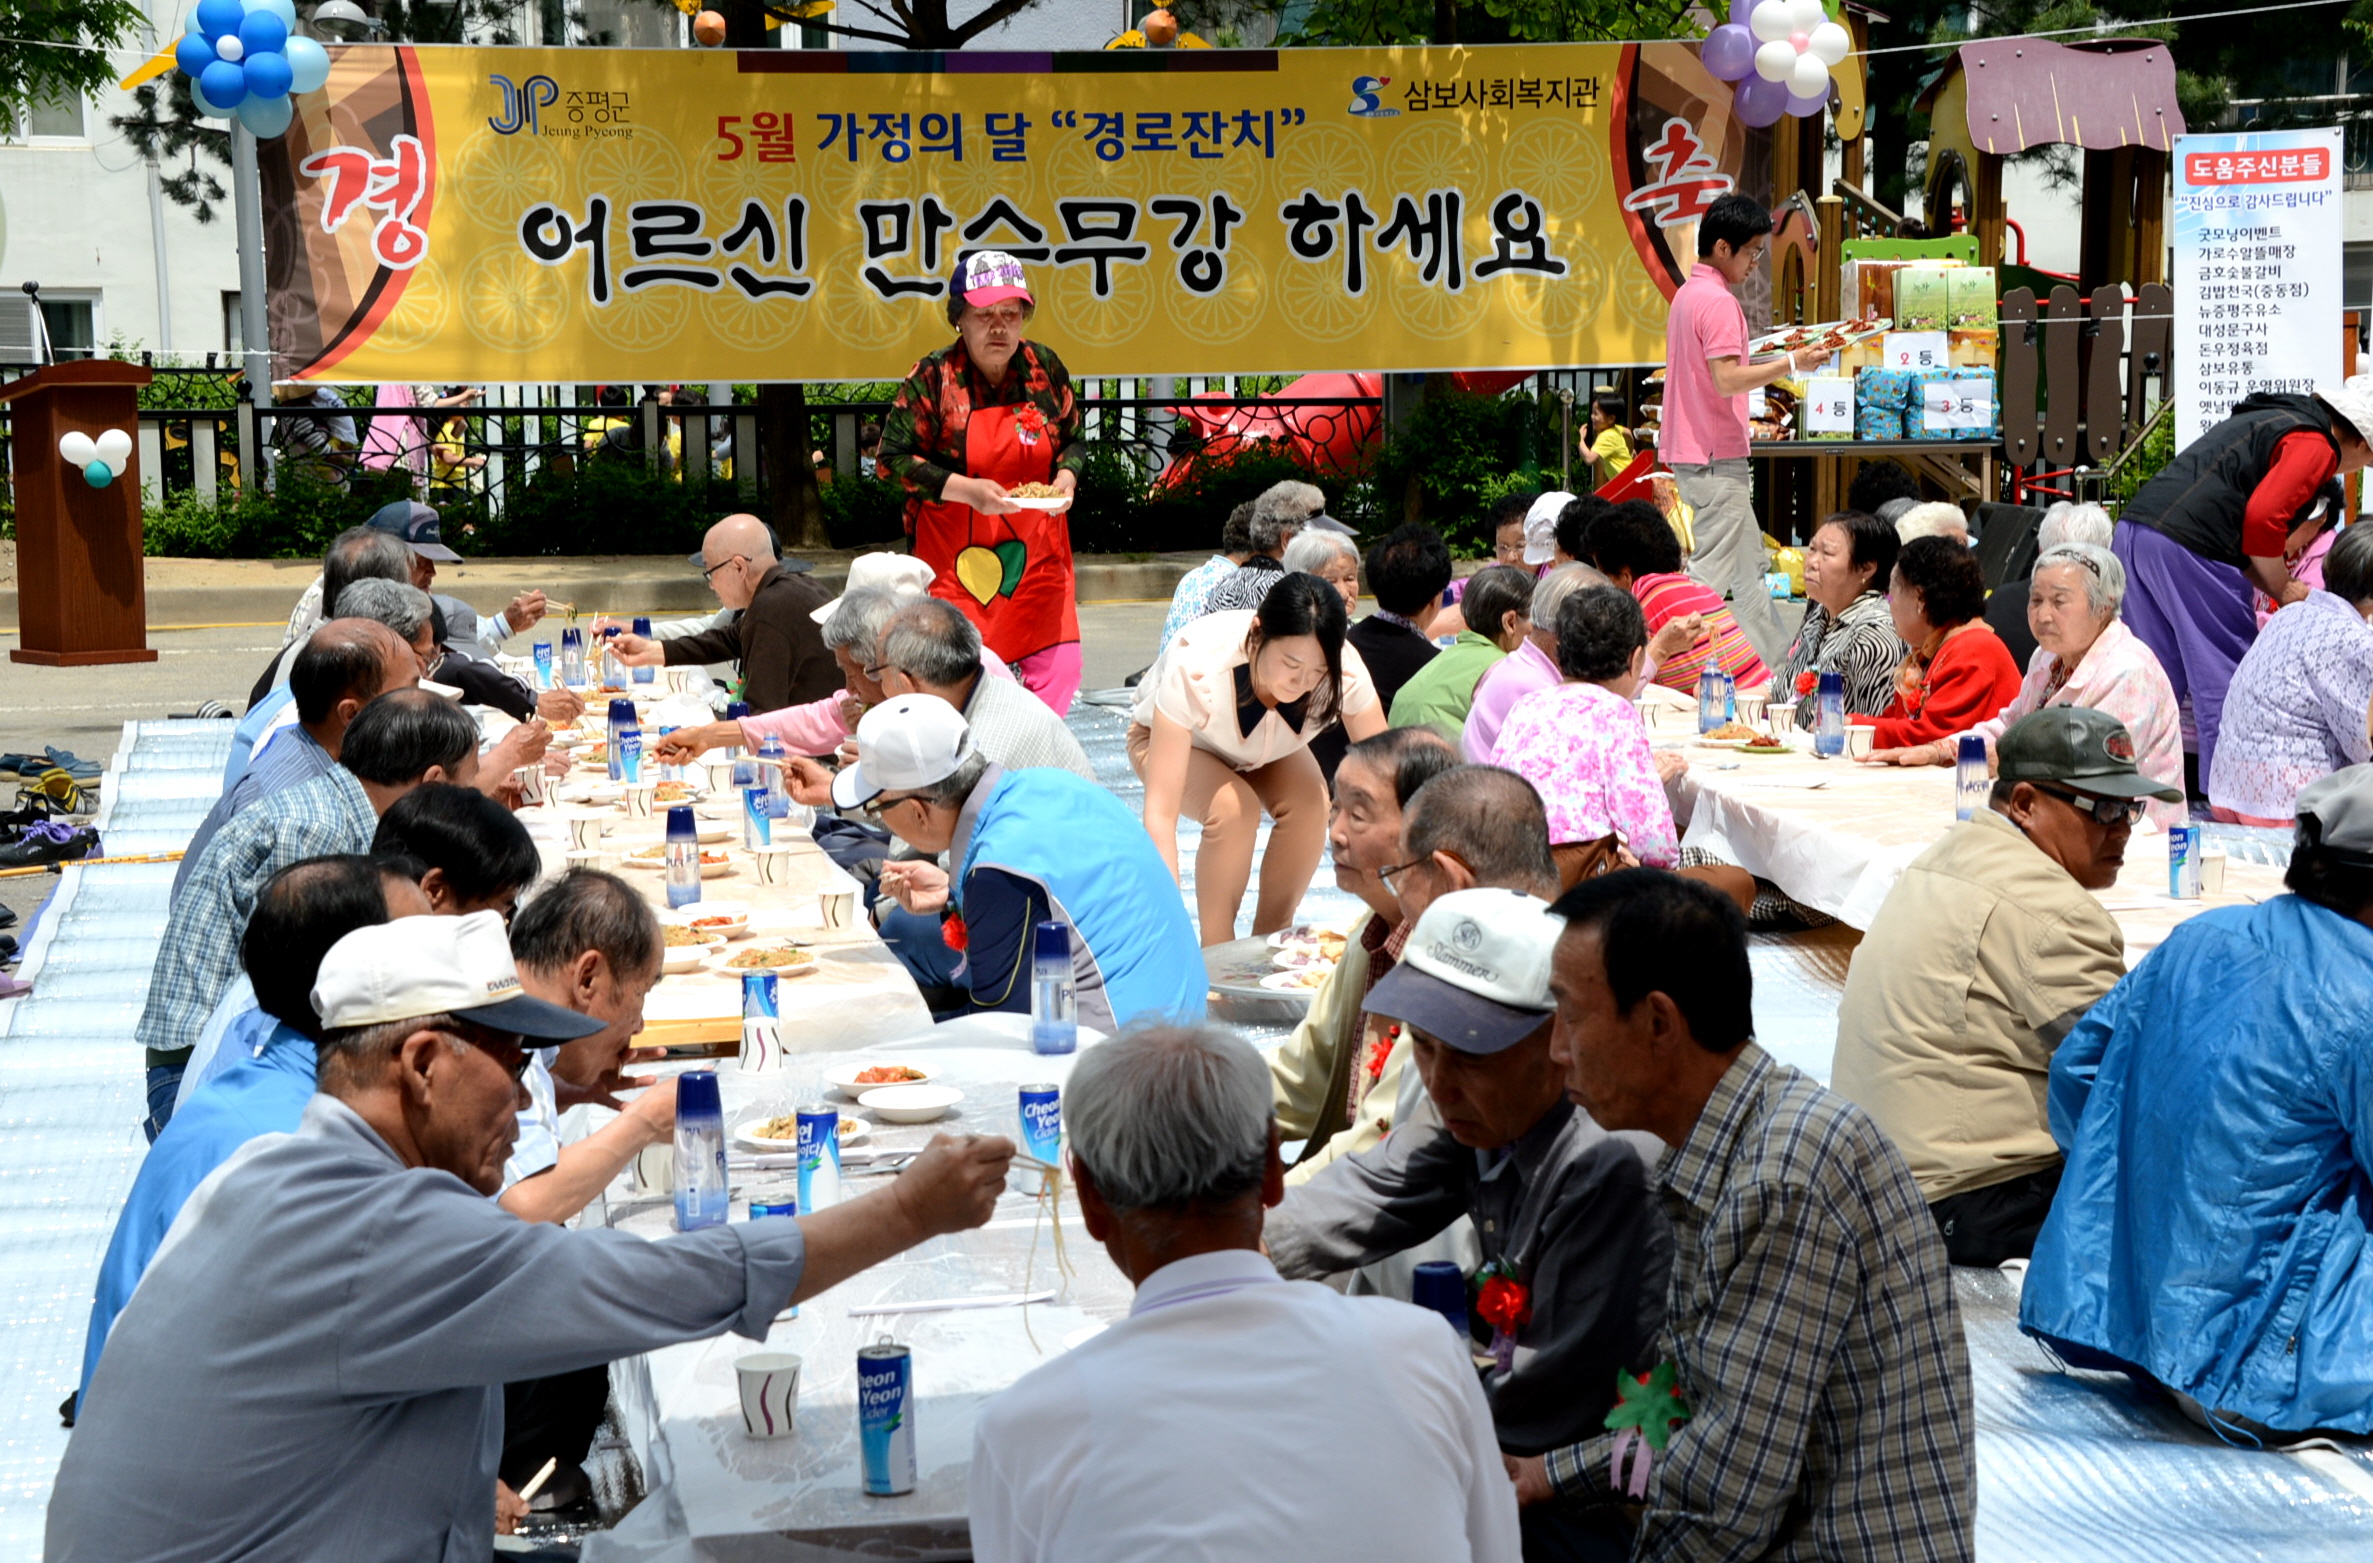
[2110,375,2373,780]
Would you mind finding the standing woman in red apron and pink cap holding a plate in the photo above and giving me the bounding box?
[880,249,1080,716]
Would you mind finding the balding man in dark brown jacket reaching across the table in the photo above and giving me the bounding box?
[612,515,840,716]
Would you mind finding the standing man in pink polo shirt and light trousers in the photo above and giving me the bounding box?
[1656,194,1825,666]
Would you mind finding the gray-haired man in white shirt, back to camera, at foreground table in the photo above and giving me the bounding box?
[971,1027,1516,1563]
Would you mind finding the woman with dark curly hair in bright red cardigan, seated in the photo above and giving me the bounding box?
[1851,536,2019,749]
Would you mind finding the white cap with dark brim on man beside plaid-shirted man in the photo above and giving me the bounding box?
[1364,889,1566,1055]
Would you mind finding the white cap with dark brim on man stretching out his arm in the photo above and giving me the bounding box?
[313,911,607,1041]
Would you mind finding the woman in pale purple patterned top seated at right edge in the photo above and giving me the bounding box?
[2207,524,2373,830]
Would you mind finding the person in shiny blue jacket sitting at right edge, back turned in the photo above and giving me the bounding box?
[2019,766,2373,1440]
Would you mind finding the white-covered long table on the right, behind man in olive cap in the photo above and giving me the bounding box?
[1649,725,2283,963]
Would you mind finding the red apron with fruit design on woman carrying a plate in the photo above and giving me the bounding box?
[914,401,1080,662]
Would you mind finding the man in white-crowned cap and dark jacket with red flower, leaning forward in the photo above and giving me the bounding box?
[1267,889,1673,1489]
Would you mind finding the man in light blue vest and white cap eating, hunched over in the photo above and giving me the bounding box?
[833,695,1210,1032]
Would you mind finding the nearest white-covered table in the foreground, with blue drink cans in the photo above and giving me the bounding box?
[584,1015,1132,1563]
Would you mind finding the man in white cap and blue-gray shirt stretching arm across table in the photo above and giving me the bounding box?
[45,913,1013,1563]
